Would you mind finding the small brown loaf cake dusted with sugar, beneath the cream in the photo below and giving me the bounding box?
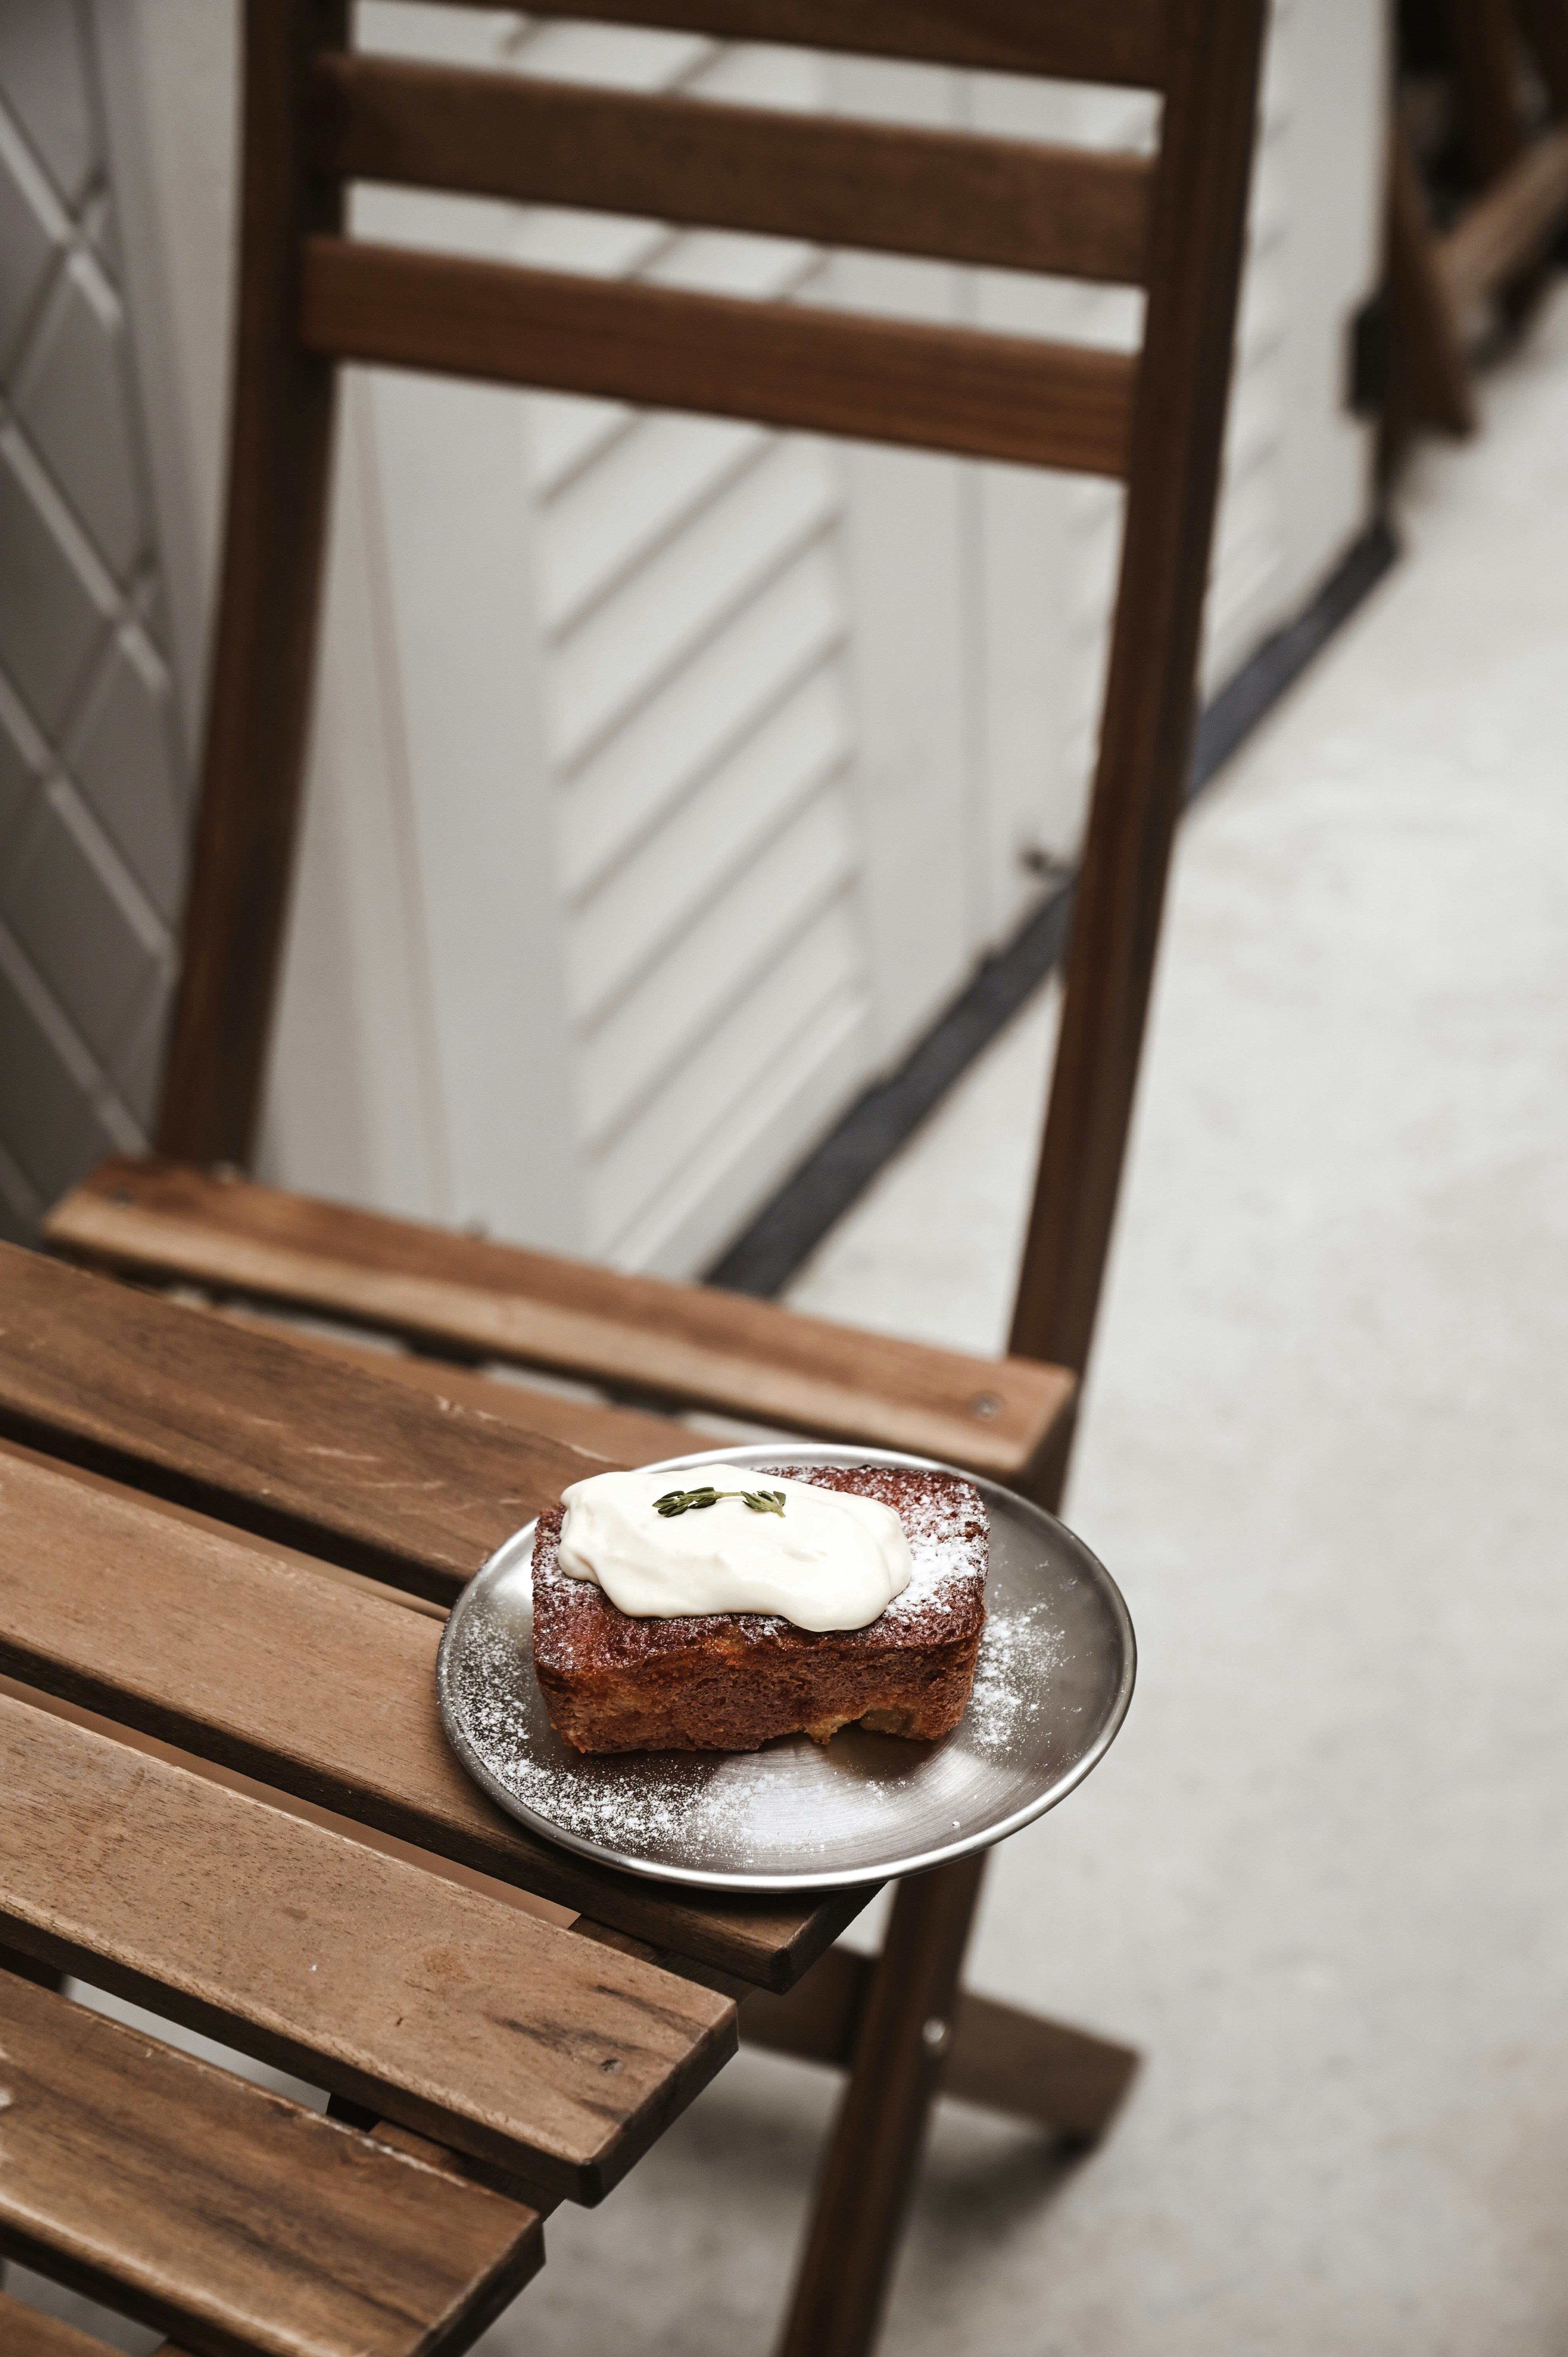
[533,1464,988,1751]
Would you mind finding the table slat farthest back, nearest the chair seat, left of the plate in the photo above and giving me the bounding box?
[0,1244,604,1603]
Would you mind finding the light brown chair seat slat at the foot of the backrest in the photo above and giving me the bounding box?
[45,1160,1075,1480]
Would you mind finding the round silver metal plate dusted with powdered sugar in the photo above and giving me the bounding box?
[436,1442,1134,1890]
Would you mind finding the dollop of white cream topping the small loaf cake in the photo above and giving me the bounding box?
[559,1464,913,1629]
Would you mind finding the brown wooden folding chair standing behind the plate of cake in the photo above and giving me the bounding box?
[47,0,1264,2357]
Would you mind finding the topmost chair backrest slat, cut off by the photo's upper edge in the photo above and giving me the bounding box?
[410,0,1167,90]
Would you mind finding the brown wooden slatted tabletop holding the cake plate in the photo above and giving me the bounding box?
[0,1247,870,2357]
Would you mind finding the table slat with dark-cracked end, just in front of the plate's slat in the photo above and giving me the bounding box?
[0,1697,736,2202]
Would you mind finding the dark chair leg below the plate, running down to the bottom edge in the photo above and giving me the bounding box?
[778,1855,985,2357]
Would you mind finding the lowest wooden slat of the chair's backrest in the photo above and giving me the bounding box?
[299,238,1137,476]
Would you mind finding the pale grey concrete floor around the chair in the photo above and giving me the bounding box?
[15,295,1568,2357]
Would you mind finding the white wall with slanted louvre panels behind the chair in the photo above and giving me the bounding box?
[85,0,1382,1273]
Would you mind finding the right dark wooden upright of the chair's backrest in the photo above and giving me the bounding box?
[1009,0,1264,1374]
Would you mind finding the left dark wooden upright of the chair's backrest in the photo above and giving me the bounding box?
[158,0,349,1162]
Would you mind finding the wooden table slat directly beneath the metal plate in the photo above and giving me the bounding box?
[0,1454,868,1989]
